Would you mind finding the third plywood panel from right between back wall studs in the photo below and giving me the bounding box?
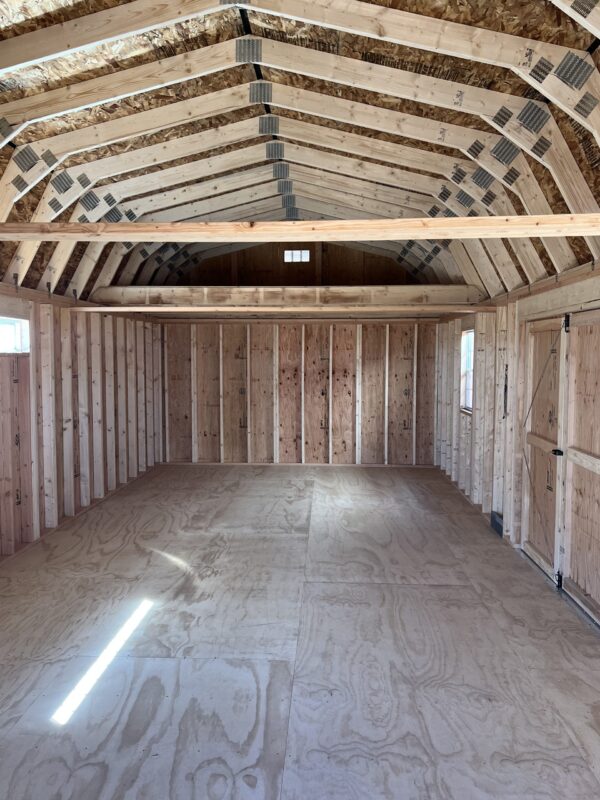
[361,324,385,464]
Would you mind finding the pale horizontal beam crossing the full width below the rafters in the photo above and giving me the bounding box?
[0,213,600,243]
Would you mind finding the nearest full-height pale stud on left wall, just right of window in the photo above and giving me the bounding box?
[40,303,59,528]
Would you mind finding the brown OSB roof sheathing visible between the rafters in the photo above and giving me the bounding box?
[0,0,600,285]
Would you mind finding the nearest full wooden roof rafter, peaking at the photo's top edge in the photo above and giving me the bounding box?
[0,0,600,136]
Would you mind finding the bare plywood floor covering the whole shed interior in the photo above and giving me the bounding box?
[0,466,600,800]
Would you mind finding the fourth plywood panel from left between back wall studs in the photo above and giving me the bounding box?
[250,324,275,464]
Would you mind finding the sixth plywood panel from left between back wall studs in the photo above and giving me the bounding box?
[304,323,330,464]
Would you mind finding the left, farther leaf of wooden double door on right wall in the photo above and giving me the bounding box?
[522,318,564,579]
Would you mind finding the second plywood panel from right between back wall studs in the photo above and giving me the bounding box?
[386,324,415,464]
